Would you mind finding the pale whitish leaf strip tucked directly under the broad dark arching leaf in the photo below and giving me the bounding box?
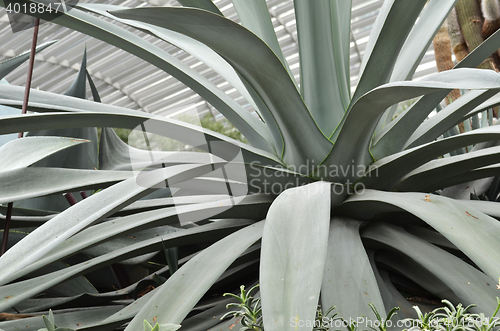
[78,4,272,150]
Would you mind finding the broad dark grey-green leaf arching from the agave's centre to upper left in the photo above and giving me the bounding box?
[111,7,331,166]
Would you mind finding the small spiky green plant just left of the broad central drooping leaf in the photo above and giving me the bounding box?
[221,284,264,331]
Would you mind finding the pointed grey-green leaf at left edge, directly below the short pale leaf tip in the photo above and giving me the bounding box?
[0,169,133,205]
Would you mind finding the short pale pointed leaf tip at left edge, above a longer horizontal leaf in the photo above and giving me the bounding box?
[0,137,89,171]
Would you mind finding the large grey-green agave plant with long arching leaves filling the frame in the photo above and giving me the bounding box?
[0,0,500,331]
